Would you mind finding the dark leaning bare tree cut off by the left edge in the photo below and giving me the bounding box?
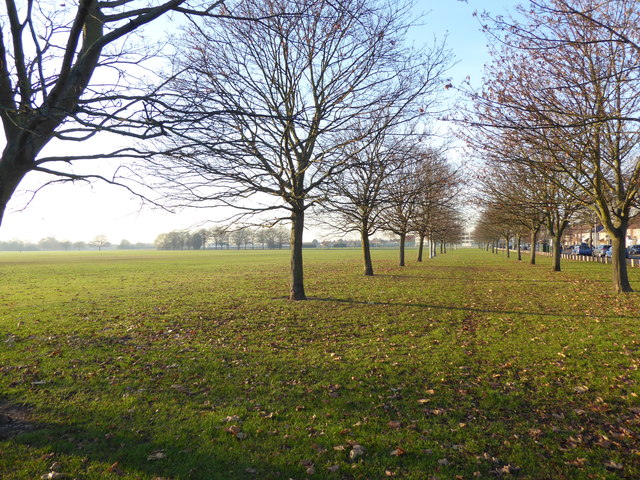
[0,0,234,226]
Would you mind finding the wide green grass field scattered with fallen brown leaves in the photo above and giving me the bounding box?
[0,249,640,480]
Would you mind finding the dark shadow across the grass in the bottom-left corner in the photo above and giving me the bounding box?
[0,401,300,480]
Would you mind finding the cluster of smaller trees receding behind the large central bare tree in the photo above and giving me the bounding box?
[321,140,464,275]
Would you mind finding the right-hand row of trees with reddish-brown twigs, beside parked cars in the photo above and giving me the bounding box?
[465,0,640,292]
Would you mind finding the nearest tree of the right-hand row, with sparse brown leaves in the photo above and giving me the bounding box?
[477,0,640,292]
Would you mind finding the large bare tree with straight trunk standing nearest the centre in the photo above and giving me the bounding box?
[146,0,449,300]
